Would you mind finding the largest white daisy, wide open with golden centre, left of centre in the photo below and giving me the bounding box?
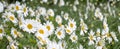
[21,19,39,33]
